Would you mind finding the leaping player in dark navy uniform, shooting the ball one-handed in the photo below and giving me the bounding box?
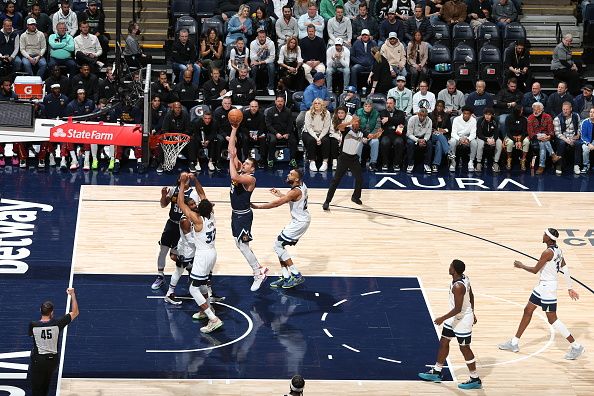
[228,120,268,291]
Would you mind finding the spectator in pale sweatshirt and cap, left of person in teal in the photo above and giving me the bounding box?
[19,18,47,78]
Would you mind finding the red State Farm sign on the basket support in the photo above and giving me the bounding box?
[50,120,142,146]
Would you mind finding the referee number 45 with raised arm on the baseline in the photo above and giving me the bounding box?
[28,288,78,396]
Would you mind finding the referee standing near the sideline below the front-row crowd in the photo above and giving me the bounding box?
[322,116,382,210]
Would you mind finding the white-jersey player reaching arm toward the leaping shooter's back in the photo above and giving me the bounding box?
[252,169,311,289]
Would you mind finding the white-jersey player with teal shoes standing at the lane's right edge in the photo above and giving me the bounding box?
[419,260,482,389]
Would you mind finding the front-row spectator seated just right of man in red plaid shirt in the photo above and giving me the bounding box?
[553,102,582,175]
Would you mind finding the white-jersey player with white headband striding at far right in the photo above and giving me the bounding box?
[499,228,585,360]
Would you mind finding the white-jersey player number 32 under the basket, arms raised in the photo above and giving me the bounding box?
[178,174,223,333]
